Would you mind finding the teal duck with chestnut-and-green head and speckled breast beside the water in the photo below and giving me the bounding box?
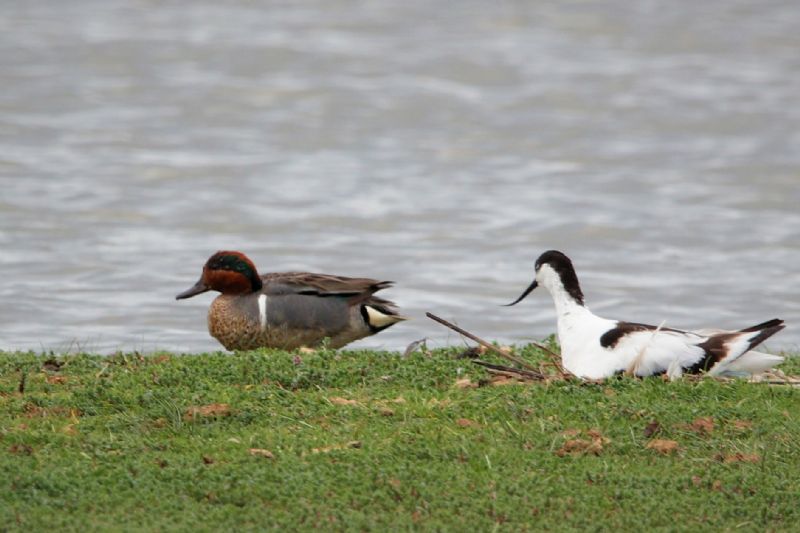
[175,250,406,351]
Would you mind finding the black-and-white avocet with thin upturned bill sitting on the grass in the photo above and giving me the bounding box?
[508,250,785,379]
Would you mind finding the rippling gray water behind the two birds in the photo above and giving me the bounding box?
[0,0,800,353]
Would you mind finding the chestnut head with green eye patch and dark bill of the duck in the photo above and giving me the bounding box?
[175,251,262,300]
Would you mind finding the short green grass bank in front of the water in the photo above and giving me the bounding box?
[0,342,800,531]
